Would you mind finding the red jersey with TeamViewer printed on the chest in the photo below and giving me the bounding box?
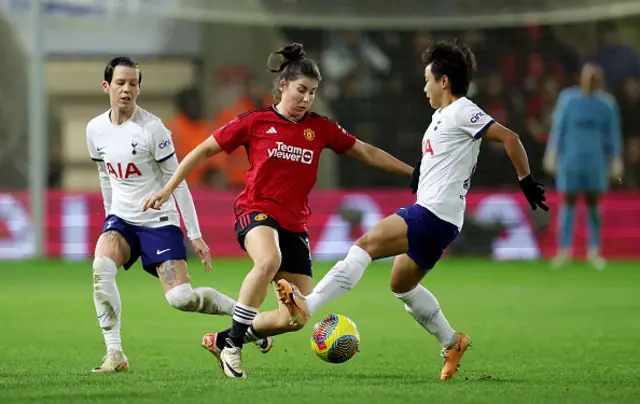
[212,106,356,232]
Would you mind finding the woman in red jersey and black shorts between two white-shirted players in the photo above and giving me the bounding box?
[143,44,413,378]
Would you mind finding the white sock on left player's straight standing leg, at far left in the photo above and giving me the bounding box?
[93,257,122,351]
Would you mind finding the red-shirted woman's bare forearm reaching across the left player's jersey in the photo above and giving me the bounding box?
[142,136,222,212]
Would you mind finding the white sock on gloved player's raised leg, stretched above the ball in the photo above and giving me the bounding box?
[306,245,371,314]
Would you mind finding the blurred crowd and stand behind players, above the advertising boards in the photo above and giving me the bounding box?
[0,0,640,256]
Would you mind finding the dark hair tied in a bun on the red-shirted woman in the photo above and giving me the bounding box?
[267,43,322,99]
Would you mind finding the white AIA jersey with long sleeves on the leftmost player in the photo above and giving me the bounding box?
[87,107,200,239]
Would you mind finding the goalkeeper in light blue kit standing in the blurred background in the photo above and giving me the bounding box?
[543,64,623,270]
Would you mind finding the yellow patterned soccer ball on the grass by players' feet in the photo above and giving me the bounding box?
[311,314,360,363]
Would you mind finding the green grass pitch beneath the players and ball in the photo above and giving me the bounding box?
[0,259,640,404]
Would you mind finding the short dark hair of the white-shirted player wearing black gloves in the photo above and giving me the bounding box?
[422,41,476,97]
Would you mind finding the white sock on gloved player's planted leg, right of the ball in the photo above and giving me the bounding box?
[394,285,456,348]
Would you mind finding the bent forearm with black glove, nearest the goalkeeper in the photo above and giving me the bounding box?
[484,123,549,211]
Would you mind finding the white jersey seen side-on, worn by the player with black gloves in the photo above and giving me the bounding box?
[417,97,494,229]
